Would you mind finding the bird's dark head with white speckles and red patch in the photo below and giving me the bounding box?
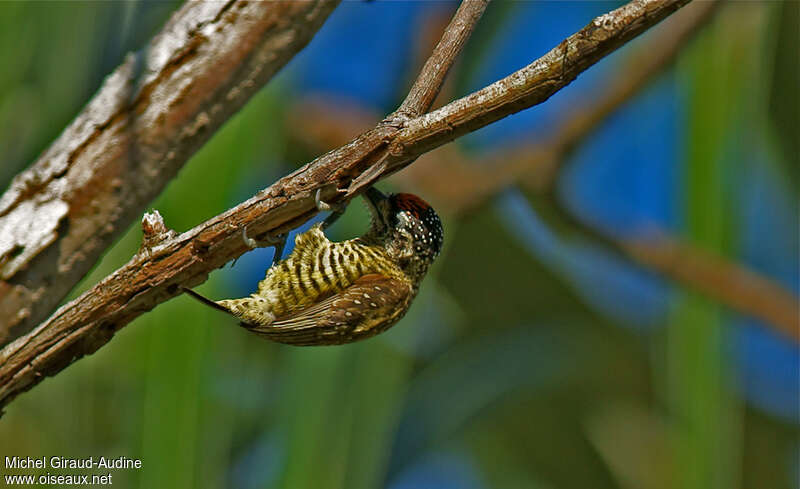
[364,187,444,278]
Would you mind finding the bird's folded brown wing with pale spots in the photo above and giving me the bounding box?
[245,273,413,345]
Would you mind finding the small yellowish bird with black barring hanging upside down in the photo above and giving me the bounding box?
[184,187,443,345]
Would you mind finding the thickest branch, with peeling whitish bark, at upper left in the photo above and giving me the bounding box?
[0,0,338,343]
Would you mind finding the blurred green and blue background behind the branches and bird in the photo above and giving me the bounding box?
[0,1,800,489]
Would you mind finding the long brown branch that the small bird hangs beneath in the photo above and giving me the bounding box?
[0,0,688,412]
